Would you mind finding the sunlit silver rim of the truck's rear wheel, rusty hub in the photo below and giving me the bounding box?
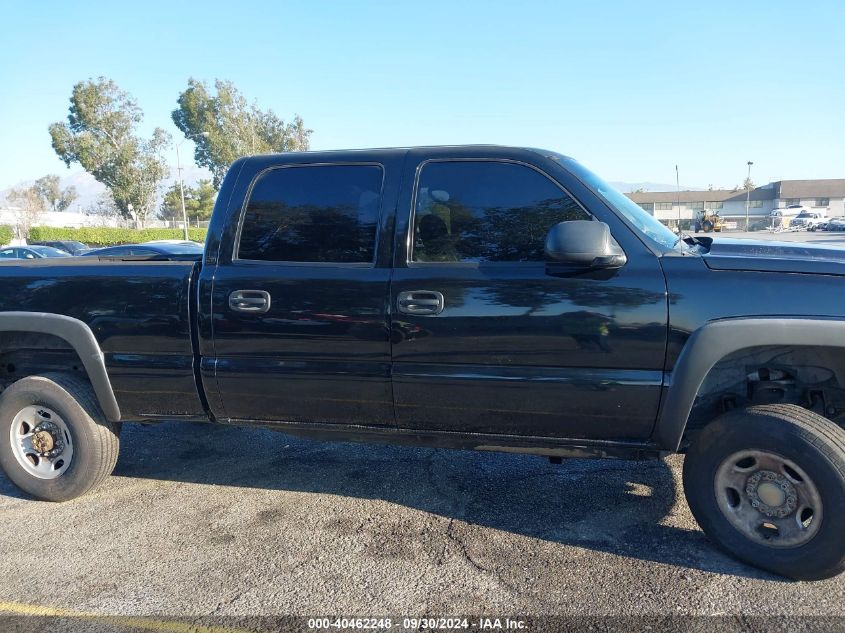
[9,405,73,479]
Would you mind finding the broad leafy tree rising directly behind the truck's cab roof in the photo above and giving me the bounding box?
[172,79,312,189]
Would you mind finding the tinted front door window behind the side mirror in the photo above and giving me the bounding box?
[412,161,590,262]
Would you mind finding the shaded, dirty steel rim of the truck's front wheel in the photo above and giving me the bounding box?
[714,450,823,548]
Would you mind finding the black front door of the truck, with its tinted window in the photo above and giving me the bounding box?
[391,149,667,439]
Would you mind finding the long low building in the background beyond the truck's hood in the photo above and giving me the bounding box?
[627,178,845,230]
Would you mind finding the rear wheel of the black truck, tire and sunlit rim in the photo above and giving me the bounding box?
[0,374,120,501]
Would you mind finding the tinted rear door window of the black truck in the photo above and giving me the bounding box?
[238,165,382,263]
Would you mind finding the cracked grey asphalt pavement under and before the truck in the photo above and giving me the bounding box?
[0,423,845,616]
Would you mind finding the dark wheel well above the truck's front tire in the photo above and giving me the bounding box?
[681,345,845,450]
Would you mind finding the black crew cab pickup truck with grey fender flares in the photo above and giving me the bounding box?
[0,146,845,579]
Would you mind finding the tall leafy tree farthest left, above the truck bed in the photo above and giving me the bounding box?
[50,77,170,225]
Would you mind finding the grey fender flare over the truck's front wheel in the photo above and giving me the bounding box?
[653,317,845,451]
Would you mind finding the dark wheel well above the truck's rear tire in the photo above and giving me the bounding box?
[0,332,89,392]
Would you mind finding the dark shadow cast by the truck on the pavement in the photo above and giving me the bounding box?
[0,423,782,580]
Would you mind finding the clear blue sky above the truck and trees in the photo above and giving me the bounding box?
[0,0,845,189]
